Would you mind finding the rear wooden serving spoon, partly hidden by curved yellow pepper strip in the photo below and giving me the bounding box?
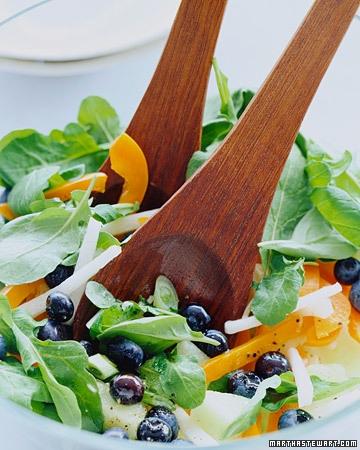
[93,0,227,209]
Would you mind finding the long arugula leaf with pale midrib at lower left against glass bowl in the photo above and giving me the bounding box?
[0,295,102,431]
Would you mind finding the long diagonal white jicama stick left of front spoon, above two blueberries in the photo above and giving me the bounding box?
[19,245,121,317]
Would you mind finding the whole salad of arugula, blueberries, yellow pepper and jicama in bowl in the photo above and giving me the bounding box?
[0,61,360,446]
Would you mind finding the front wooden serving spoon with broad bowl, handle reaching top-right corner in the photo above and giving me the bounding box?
[74,0,359,335]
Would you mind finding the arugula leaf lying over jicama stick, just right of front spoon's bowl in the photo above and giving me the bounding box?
[251,259,303,326]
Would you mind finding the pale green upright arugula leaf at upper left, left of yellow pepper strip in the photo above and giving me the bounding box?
[8,166,59,215]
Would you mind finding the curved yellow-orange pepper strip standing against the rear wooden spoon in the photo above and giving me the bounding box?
[109,133,149,203]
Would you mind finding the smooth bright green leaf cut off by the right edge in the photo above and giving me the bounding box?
[310,186,360,247]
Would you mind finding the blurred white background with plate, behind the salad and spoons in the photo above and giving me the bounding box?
[0,0,360,151]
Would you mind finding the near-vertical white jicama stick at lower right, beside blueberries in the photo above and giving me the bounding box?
[286,347,314,408]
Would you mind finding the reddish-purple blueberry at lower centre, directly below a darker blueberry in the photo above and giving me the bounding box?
[110,374,144,405]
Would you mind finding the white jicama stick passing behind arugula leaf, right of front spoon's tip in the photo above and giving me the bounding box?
[224,283,342,334]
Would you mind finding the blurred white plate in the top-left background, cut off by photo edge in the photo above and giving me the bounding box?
[0,0,179,62]
